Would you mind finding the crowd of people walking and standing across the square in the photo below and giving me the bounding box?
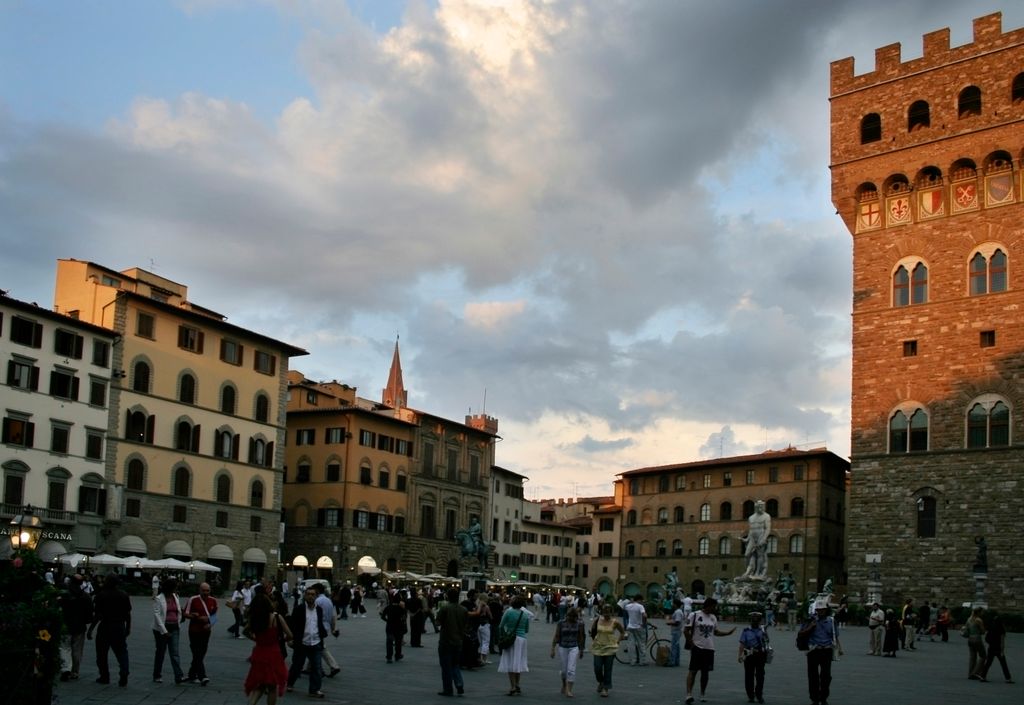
[49,575,1013,705]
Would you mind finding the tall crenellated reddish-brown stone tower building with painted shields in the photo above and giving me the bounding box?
[830,13,1024,610]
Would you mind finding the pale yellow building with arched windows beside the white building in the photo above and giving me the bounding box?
[54,259,305,582]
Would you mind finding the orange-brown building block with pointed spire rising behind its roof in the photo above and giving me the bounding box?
[284,342,497,581]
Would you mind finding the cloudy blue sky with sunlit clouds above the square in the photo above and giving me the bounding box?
[0,0,1024,499]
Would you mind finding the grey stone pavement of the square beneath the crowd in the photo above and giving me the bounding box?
[56,597,1024,705]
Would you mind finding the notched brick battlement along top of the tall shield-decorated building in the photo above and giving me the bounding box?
[830,12,1024,97]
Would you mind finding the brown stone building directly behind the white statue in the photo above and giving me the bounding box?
[614,448,850,598]
